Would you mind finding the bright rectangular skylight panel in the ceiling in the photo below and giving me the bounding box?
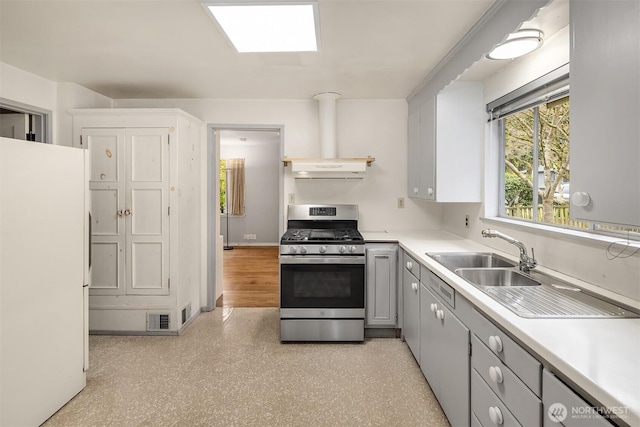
[207,2,318,52]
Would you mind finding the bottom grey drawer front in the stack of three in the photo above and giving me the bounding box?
[471,370,521,427]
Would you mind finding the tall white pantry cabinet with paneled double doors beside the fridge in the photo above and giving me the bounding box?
[70,109,202,334]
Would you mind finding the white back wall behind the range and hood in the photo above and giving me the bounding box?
[115,99,443,231]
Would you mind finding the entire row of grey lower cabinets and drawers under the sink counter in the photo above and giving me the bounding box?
[401,252,626,427]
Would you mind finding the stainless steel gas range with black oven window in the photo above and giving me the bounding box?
[280,205,365,341]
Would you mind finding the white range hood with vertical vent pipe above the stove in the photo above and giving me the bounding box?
[283,92,375,179]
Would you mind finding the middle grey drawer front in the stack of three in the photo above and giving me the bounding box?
[471,335,542,426]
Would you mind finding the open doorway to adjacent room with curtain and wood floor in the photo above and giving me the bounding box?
[207,125,283,309]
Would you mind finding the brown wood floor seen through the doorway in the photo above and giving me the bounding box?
[217,246,280,307]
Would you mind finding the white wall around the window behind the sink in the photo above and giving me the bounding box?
[444,28,640,301]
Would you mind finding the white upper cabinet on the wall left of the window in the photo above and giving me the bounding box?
[408,82,484,202]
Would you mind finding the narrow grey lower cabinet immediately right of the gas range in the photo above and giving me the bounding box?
[365,243,398,328]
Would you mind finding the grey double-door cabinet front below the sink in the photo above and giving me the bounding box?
[420,272,470,426]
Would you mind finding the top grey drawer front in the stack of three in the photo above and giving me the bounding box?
[473,310,542,397]
